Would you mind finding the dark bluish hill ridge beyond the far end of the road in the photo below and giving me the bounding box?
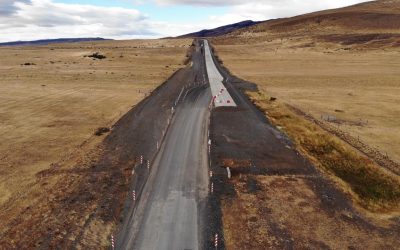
[178,20,260,38]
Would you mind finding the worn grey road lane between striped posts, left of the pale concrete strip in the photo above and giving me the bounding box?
[116,39,211,250]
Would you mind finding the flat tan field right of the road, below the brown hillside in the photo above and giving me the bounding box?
[216,44,400,162]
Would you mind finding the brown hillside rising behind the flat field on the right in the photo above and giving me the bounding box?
[219,0,400,47]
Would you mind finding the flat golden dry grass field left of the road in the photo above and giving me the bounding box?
[0,39,192,246]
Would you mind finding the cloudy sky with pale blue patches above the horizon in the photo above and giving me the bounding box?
[0,0,365,42]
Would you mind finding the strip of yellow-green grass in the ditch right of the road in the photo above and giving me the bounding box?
[248,92,400,212]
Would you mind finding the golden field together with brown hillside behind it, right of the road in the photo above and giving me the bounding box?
[214,0,400,166]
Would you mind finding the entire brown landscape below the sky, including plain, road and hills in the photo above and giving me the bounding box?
[0,0,400,249]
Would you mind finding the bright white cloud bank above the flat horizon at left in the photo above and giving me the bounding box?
[0,0,166,41]
